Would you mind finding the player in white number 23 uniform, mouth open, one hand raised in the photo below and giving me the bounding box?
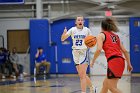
[61,16,96,93]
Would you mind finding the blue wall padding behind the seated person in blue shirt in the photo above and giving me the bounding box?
[30,20,50,74]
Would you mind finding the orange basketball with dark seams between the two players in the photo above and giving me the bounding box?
[84,36,97,48]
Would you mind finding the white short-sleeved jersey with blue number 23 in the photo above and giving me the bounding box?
[66,27,91,49]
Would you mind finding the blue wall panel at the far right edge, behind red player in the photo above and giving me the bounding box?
[129,18,140,73]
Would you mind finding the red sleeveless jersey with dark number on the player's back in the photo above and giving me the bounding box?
[103,31,122,59]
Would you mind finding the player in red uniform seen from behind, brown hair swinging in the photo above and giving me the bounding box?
[90,18,133,93]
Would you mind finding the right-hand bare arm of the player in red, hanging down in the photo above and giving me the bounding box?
[120,43,133,72]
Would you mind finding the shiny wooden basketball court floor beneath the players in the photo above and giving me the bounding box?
[0,75,140,93]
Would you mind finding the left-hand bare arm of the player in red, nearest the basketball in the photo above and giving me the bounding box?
[90,33,105,67]
